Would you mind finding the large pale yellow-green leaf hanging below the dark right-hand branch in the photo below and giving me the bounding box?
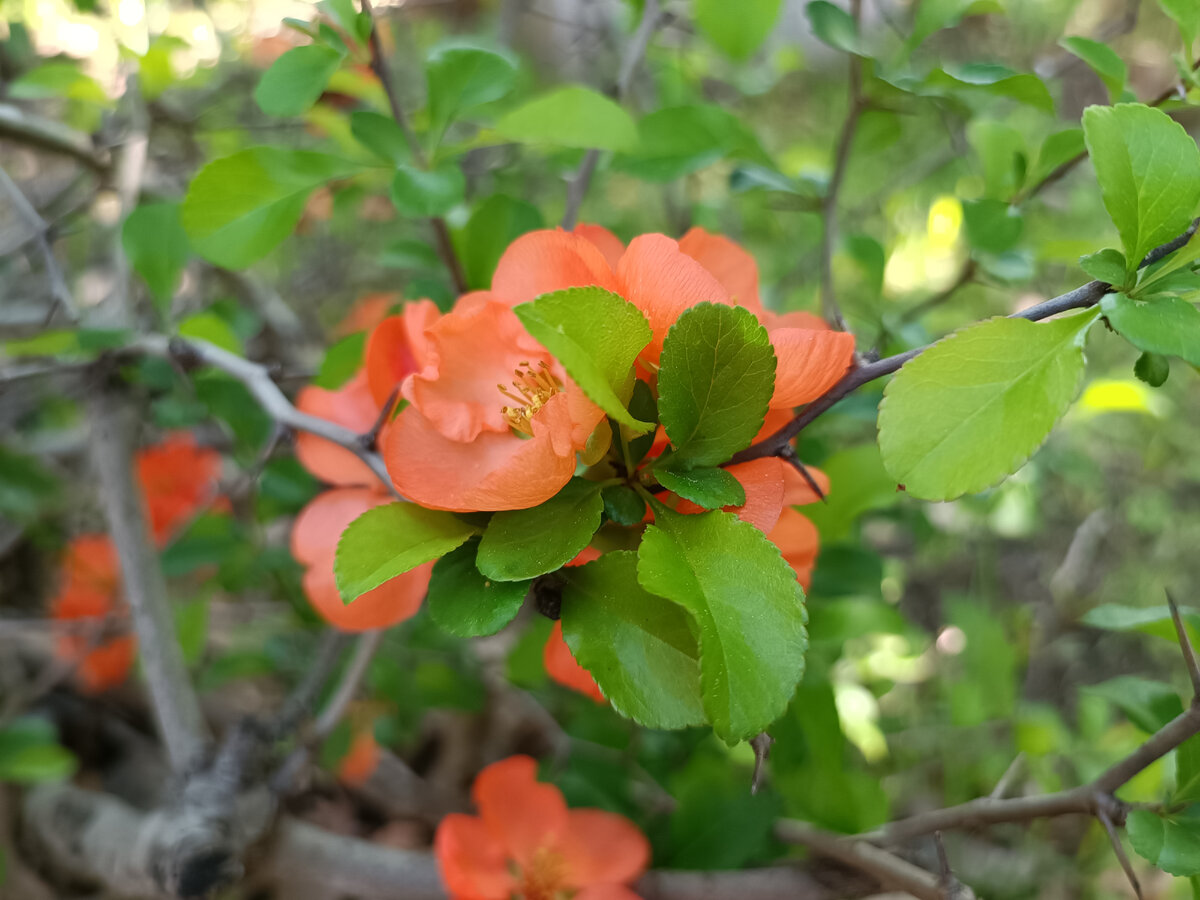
[878,310,1097,500]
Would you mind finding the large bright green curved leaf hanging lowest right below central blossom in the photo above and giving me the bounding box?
[637,509,808,744]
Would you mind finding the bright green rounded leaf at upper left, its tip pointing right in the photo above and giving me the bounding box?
[181,146,359,269]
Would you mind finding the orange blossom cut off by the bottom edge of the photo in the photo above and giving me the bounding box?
[433,756,650,900]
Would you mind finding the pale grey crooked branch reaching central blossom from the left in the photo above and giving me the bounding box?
[124,335,391,487]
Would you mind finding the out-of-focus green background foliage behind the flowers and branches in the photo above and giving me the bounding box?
[0,0,1200,898]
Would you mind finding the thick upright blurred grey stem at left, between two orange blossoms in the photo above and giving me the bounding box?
[88,385,209,772]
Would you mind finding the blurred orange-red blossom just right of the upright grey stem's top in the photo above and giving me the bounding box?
[137,432,221,545]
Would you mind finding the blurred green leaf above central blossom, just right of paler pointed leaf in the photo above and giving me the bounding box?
[612,104,773,182]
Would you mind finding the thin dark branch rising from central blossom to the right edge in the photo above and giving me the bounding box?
[731,218,1200,462]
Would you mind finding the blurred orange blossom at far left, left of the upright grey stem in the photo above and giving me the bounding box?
[50,534,136,694]
